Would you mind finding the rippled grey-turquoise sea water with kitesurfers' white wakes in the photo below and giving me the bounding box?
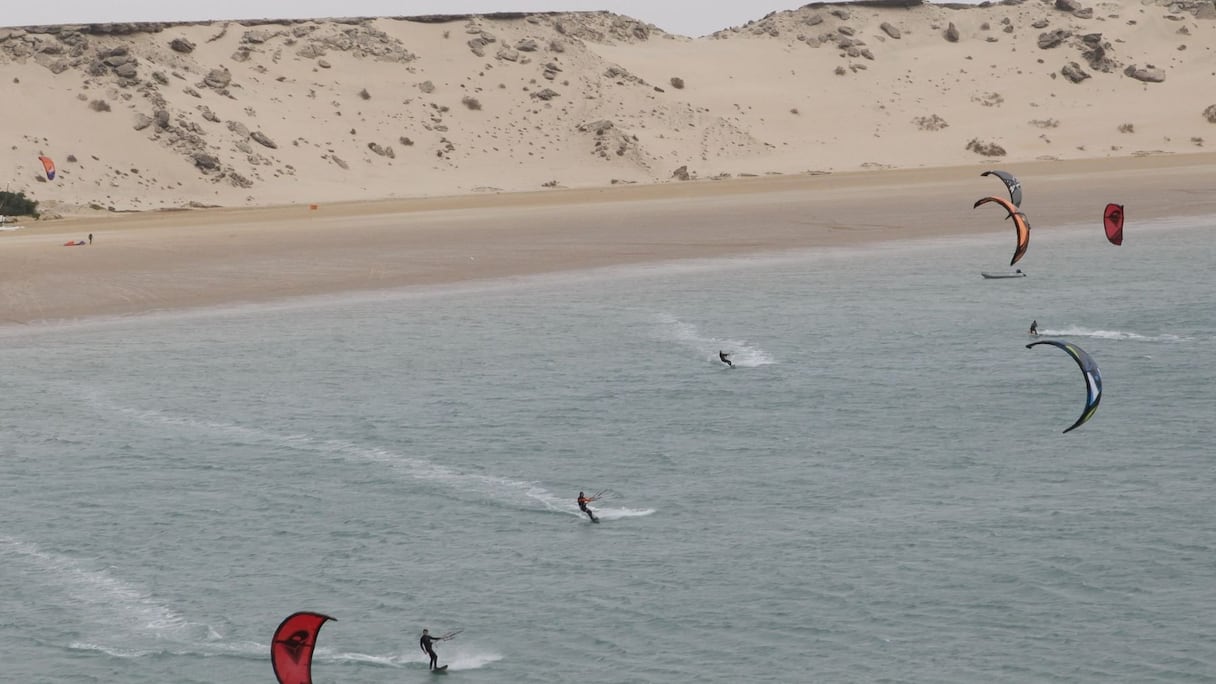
[0,214,1216,684]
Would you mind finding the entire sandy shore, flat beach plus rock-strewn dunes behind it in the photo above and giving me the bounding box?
[0,1,1216,325]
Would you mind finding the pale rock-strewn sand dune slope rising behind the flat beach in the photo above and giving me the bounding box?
[0,1,1216,214]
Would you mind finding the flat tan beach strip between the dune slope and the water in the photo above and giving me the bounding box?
[7,153,1216,326]
